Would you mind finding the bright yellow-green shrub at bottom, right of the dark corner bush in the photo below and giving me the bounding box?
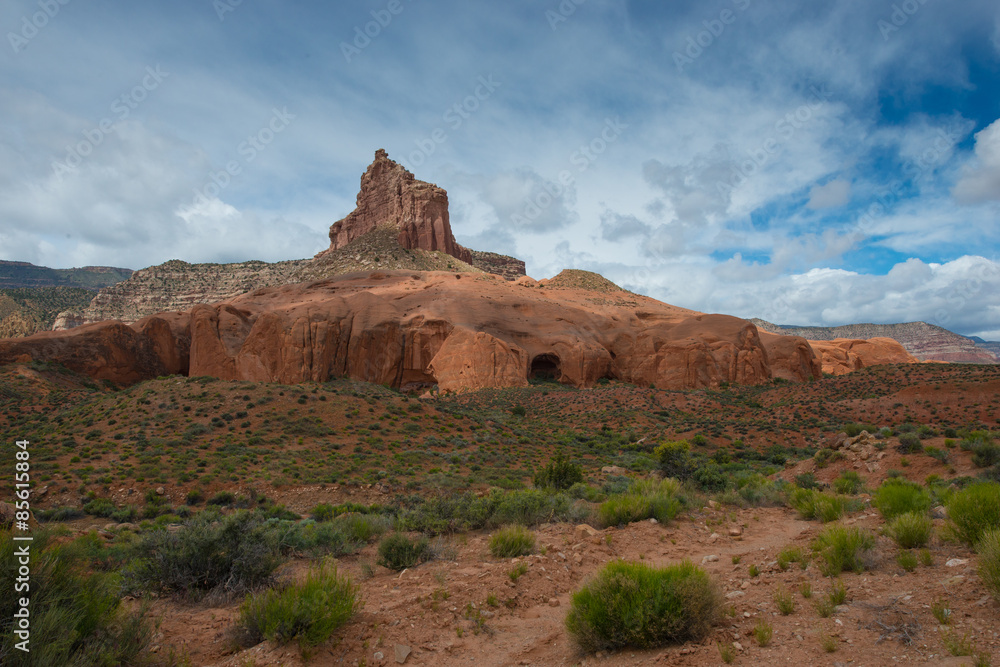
[239,563,361,647]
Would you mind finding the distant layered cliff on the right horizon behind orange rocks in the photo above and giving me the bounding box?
[750,319,1000,364]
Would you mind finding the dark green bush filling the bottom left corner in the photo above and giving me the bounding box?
[0,530,153,667]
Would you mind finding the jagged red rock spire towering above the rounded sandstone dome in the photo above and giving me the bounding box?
[317,148,472,264]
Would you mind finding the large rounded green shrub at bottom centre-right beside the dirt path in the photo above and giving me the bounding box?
[566,561,722,652]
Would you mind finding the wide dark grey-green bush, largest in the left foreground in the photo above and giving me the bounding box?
[124,511,282,597]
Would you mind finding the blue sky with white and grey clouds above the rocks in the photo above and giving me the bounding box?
[0,0,1000,340]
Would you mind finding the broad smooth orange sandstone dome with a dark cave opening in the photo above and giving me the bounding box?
[0,271,819,391]
